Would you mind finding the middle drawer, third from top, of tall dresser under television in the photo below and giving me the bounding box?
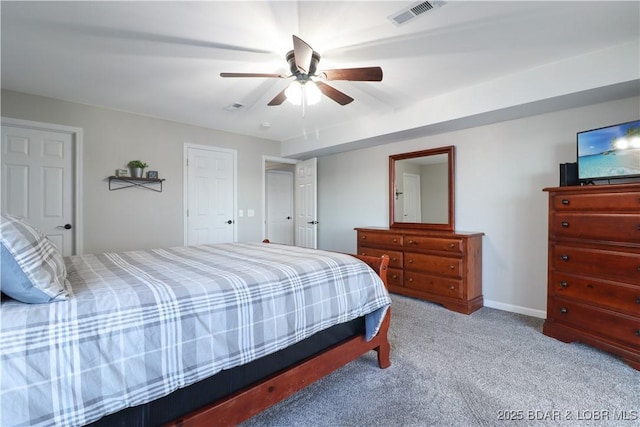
[549,245,640,285]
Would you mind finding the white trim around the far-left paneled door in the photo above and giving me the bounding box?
[1,117,84,255]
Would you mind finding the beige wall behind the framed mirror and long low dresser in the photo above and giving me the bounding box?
[318,97,640,317]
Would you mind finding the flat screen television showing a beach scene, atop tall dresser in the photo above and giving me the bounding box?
[577,120,640,182]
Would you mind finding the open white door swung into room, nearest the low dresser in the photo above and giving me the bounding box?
[295,158,318,249]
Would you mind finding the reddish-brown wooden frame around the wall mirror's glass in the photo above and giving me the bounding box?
[389,145,455,231]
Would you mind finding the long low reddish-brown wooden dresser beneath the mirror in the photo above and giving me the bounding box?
[356,228,483,314]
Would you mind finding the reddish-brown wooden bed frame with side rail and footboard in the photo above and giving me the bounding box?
[166,251,391,427]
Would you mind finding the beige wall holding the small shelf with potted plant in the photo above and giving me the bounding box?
[2,90,280,253]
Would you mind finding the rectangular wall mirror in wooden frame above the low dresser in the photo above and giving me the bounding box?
[389,145,455,231]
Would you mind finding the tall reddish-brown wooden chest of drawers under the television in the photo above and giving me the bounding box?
[543,184,640,370]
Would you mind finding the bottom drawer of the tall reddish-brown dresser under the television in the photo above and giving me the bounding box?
[547,298,640,349]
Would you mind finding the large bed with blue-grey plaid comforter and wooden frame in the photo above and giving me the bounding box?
[0,216,390,426]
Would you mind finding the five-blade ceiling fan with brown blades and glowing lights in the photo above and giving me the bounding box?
[220,35,382,106]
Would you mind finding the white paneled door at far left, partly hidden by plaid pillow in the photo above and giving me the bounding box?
[2,125,76,256]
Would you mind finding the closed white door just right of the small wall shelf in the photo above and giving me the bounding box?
[185,146,236,245]
